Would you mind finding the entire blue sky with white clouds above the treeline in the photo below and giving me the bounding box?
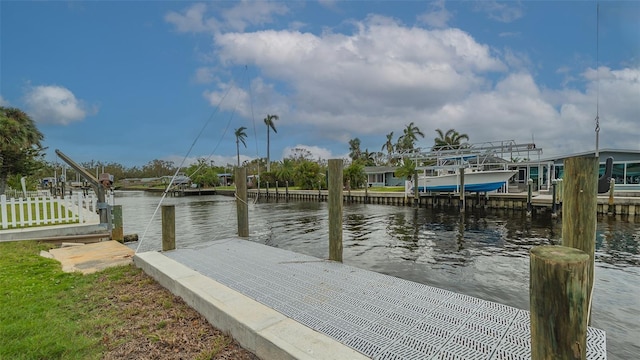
[0,0,640,167]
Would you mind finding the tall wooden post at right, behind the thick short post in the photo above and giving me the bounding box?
[562,156,598,324]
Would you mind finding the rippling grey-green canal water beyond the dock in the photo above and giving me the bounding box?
[115,191,640,360]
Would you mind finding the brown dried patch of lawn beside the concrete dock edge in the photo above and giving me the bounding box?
[96,266,258,360]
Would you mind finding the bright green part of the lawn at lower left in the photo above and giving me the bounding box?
[0,241,128,359]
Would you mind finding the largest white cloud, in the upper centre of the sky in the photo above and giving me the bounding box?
[215,16,507,139]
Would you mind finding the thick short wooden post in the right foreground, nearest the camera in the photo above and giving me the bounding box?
[529,245,589,360]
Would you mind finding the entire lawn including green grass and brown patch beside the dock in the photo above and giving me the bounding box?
[0,241,253,359]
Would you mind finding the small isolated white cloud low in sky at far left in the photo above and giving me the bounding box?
[25,85,97,125]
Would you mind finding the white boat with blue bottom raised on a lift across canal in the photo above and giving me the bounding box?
[418,168,517,192]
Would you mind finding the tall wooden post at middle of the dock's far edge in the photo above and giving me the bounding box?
[327,159,343,262]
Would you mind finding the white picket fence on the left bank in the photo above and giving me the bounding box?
[0,193,113,230]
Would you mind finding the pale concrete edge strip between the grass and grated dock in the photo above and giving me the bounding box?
[134,252,368,360]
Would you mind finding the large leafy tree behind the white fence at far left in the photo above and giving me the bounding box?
[0,106,44,194]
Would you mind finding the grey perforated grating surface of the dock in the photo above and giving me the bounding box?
[164,239,606,360]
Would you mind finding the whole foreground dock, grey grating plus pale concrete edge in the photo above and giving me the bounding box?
[134,238,607,360]
